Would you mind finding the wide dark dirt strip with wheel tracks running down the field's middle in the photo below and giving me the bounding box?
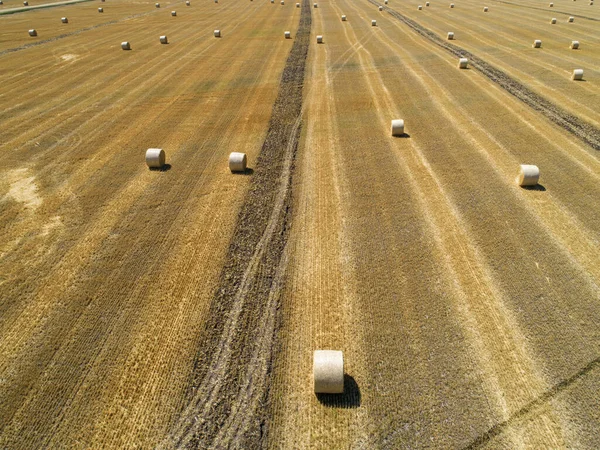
[162,0,311,448]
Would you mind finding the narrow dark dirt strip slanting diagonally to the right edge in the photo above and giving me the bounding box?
[368,0,600,150]
